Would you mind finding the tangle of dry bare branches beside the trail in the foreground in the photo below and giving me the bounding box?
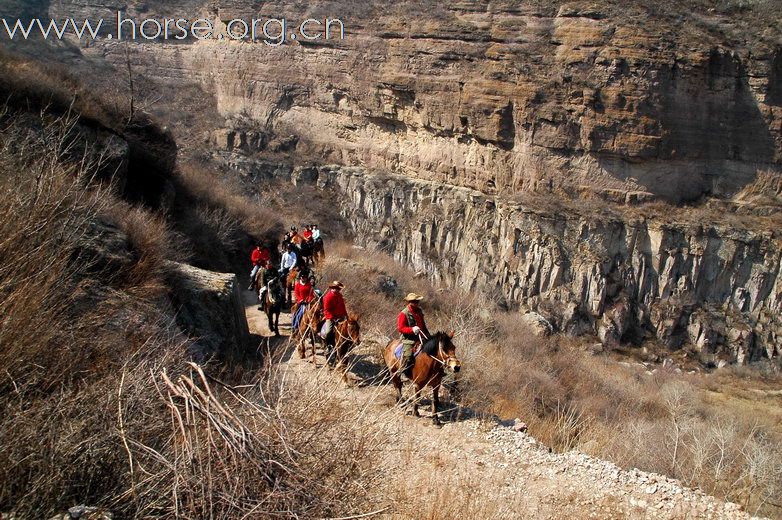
[114,364,385,519]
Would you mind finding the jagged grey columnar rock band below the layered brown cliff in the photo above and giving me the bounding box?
[293,167,782,364]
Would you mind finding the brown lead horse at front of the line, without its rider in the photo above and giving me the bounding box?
[383,332,462,426]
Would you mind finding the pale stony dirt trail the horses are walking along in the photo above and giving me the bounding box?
[240,292,760,519]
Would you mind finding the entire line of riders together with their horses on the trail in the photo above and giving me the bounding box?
[250,225,461,424]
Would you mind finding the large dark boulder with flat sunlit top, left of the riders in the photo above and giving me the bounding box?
[168,262,250,360]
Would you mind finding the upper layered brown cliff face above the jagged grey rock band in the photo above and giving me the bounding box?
[49,0,782,202]
